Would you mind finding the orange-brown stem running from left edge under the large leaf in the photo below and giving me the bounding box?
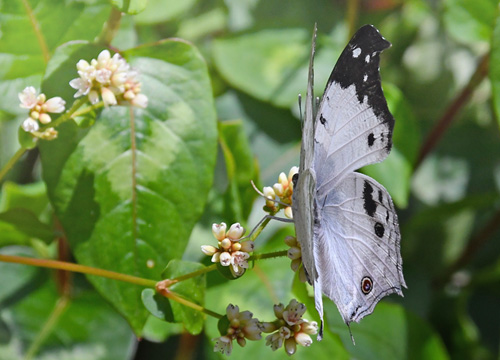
[0,254,157,288]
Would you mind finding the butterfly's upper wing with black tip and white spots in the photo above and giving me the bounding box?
[313,25,394,192]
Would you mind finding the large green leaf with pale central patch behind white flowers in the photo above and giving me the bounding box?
[40,40,216,335]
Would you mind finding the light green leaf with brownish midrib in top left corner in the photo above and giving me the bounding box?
[0,0,111,114]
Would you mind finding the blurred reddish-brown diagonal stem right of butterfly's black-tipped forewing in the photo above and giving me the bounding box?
[415,54,490,169]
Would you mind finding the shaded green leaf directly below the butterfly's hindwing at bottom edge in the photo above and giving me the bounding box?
[325,301,449,359]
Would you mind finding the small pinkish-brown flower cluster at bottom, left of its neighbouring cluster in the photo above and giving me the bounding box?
[213,304,262,356]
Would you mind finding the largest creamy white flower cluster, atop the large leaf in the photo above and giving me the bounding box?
[69,50,148,108]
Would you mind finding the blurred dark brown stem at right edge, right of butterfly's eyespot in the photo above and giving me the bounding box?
[434,209,500,288]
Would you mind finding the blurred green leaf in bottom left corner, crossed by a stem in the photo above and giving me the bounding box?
[0,278,135,360]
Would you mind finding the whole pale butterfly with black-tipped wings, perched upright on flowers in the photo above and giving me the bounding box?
[292,25,406,341]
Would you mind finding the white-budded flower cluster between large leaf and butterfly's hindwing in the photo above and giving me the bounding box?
[201,223,255,277]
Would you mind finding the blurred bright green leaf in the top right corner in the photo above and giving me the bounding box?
[444,0,498,43]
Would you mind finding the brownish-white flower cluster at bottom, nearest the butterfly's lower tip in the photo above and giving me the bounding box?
[262,299,318,355]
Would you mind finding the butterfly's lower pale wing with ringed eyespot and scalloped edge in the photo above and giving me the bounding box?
[314,172,406,323]
